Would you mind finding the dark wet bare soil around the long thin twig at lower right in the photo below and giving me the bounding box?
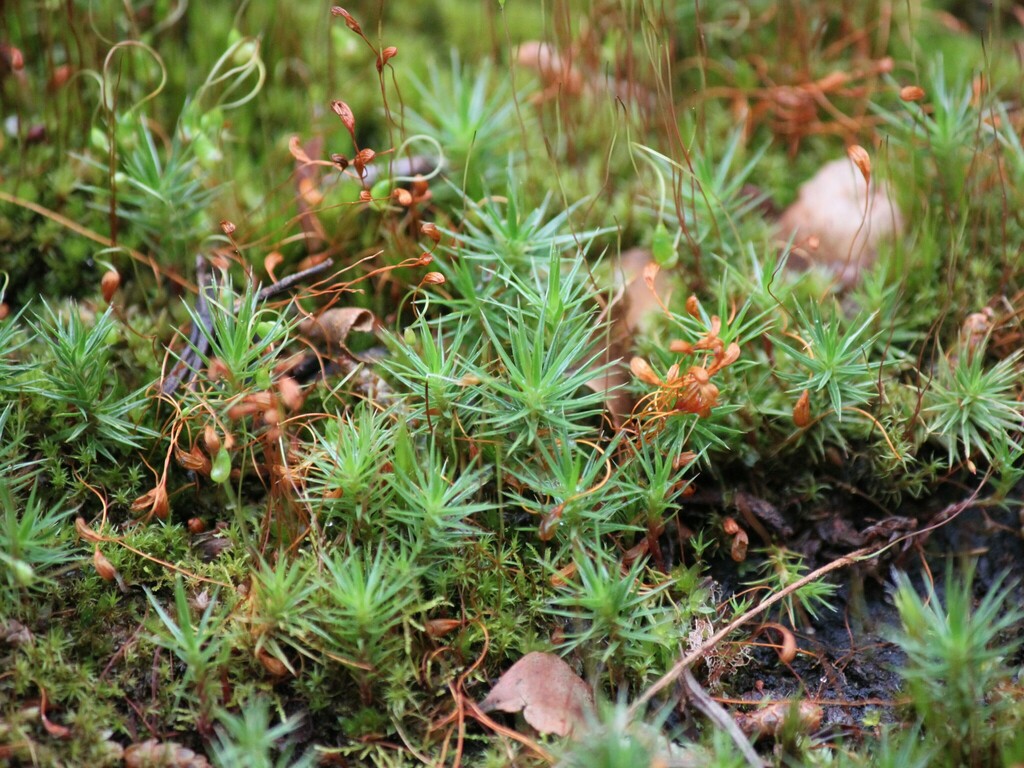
[671,481,1024,739]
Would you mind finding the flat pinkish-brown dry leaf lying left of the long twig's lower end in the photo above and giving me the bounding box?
[480,651,594,736]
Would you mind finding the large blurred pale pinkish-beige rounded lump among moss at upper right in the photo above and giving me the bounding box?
[776,158,903,288]
